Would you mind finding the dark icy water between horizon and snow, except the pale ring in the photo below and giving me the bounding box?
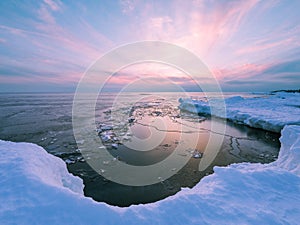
[0,93,279,206]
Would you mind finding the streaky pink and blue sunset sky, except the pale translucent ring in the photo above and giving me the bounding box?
[0,0,300,92]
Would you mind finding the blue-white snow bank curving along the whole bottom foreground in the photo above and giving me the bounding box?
[0,126,300,225]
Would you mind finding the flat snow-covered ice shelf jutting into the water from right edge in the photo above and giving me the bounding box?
[179,92,300,133]
